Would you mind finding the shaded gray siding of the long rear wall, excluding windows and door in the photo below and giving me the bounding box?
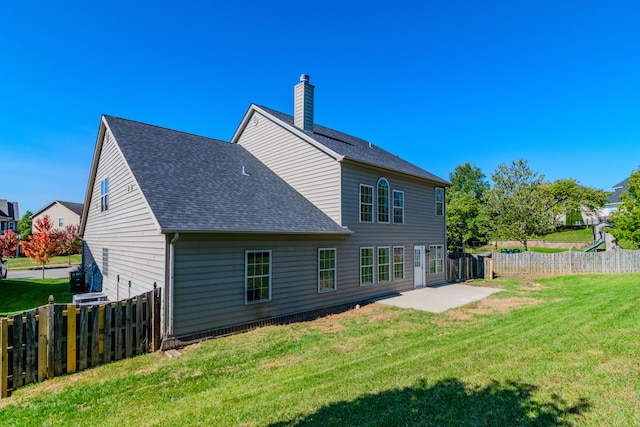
[173,162,446,336]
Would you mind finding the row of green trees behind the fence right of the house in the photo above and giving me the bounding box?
[447,159,640,251]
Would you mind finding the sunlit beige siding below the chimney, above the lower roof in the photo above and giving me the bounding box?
[238,112,342,224]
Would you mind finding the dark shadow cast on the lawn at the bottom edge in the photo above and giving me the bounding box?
[272,379,590,427]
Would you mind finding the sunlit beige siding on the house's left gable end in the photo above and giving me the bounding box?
[83,132,166,300]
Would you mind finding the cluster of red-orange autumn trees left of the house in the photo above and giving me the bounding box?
[0,215,82,279]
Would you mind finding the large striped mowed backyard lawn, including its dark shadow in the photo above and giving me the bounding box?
[0,274,640,426]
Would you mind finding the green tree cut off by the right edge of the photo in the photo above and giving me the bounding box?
[609,171,640,248]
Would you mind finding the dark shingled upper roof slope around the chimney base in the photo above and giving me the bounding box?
[256,105,451,185]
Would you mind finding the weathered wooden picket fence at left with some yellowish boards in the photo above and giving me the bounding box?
[0,286,160,398]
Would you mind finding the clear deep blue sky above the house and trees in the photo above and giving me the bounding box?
[0,0,640,215]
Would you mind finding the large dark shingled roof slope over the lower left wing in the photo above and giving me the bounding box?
[105,116,350,234]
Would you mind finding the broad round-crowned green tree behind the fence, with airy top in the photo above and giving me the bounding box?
[483,159,554,251]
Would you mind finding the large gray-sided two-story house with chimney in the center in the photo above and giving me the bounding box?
[81,75,450,342]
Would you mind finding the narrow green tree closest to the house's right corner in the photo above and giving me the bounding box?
[447,162,490,251]
